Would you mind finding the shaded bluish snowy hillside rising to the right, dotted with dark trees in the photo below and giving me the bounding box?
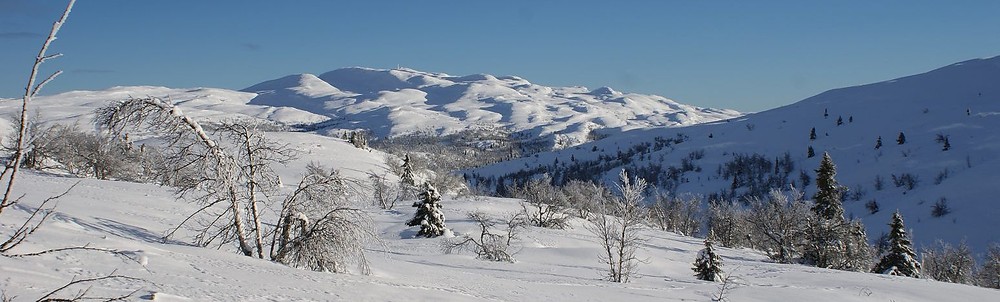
[470,57,1000,252]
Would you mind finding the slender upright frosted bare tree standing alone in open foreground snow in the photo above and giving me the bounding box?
[587,170,646,283]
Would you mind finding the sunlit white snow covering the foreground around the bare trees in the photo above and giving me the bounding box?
[0,171,1000,301]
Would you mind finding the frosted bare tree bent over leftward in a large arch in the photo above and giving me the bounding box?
[95,97,261,257]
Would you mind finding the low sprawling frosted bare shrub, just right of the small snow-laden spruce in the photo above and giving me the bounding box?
[444,211,527,262]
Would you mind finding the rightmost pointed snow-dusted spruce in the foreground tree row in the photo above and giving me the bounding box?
[872,211,920,278]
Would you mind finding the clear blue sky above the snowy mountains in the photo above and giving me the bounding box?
[0,0,1000,111]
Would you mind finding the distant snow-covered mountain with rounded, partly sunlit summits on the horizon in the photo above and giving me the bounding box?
[242,67,740,148]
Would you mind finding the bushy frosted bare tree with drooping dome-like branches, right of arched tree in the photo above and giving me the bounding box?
[270,165,379,274]
